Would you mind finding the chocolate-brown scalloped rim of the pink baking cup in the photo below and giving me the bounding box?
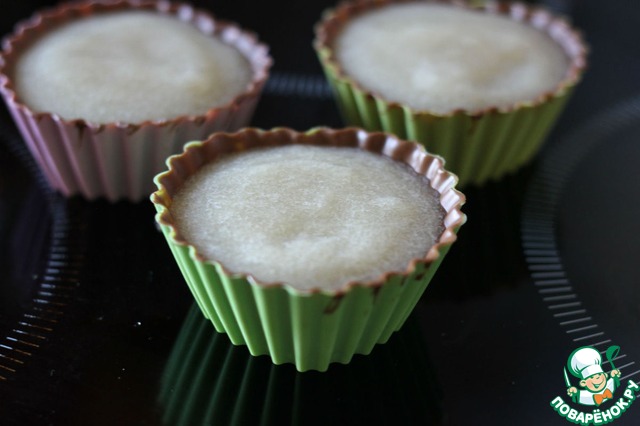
[0,0,273,133]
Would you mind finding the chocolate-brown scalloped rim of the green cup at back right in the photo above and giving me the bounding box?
[313,0,588,117]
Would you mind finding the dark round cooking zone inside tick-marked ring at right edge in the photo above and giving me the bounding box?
[555,100,640,362]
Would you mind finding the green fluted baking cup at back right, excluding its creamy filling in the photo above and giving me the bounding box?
[314,0,587,186]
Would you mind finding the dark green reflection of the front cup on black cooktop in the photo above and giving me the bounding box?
[158,305,442,425]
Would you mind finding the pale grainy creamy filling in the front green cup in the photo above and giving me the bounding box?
[170,145,444,290]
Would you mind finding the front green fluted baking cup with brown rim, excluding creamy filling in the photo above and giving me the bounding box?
[151,125,466,371]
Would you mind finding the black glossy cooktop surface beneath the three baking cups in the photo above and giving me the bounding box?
[0,0,640,425]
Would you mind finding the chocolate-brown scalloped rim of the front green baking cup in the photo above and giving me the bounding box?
[150,127,466,296]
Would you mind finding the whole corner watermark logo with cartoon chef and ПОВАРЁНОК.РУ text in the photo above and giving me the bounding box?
[551,346,640,425]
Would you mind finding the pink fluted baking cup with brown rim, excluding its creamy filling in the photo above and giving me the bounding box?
[0,0,272,201]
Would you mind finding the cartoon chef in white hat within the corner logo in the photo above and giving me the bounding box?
[565,346,620,406]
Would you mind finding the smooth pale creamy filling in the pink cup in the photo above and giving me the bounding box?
[15,11,252,123]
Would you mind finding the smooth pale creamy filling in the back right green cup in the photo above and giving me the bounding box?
[335,3,569,113]
